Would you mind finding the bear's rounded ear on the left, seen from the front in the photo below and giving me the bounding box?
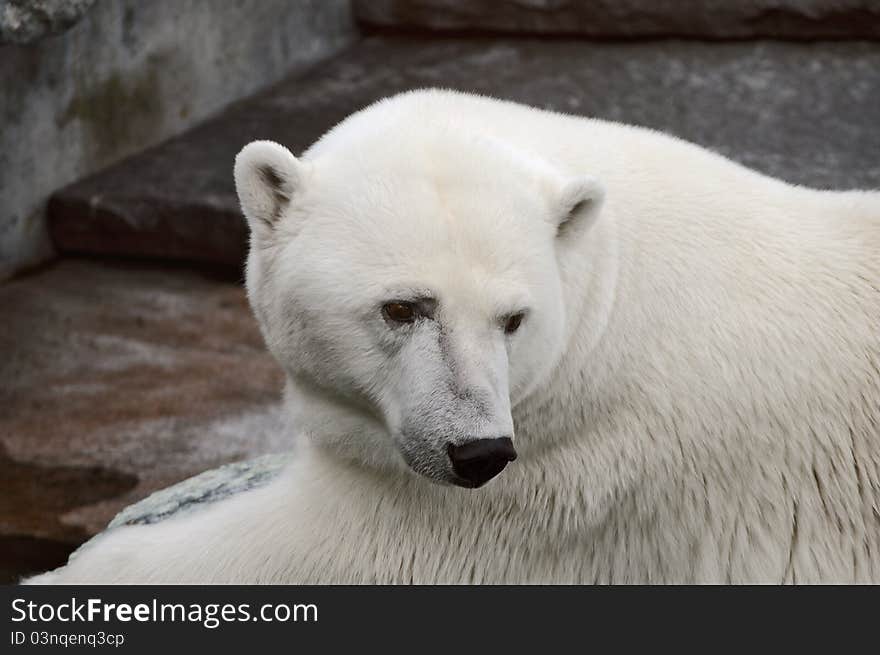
[235,141,305,235]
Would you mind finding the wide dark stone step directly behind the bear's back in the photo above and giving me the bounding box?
[50,36,880,268]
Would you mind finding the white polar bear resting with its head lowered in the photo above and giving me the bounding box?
[25,90,880,583]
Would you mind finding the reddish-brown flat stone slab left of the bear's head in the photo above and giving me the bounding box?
[0,260,290,582]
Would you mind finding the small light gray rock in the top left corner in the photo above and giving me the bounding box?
[0,0,95,43]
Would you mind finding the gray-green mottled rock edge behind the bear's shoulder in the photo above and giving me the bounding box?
[108,455,291,528]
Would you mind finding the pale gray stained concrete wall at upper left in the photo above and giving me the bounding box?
[0,0,355,279]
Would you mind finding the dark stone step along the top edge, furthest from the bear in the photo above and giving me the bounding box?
[354,0,880,39]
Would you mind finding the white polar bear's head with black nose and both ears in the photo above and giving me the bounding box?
[235,127,602,488]
